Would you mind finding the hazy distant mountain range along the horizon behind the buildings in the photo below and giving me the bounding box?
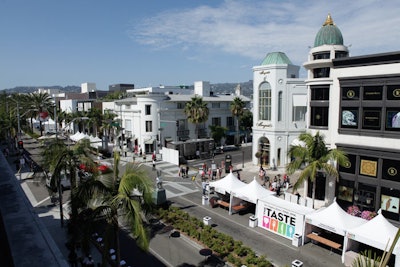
[3,80,253,97]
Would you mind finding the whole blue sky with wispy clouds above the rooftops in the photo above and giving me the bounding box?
[0,0,400,90]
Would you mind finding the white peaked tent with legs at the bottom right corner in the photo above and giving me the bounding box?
[342,211,400,267]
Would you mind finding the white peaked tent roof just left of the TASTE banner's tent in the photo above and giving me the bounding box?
[232,178,275,204]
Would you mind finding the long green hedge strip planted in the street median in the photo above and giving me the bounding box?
[157,207,273,267]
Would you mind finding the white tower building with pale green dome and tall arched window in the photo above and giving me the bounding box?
[253,52,307,168]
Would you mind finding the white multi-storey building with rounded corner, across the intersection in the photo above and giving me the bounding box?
[103,81,250,153]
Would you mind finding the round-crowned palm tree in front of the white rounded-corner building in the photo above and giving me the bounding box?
[183,95,210,138]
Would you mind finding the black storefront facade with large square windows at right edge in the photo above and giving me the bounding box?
[333,52,400,225]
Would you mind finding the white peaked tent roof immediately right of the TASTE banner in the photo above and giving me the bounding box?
[306,200,367,236]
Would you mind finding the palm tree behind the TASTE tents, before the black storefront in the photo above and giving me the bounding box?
[286,132,348,207]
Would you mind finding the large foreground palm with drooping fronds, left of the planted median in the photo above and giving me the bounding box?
[74,153,153,265]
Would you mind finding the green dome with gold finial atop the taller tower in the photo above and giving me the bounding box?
[314,14,343,47]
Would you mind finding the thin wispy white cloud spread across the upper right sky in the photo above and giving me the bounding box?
[129,0,400,64]
